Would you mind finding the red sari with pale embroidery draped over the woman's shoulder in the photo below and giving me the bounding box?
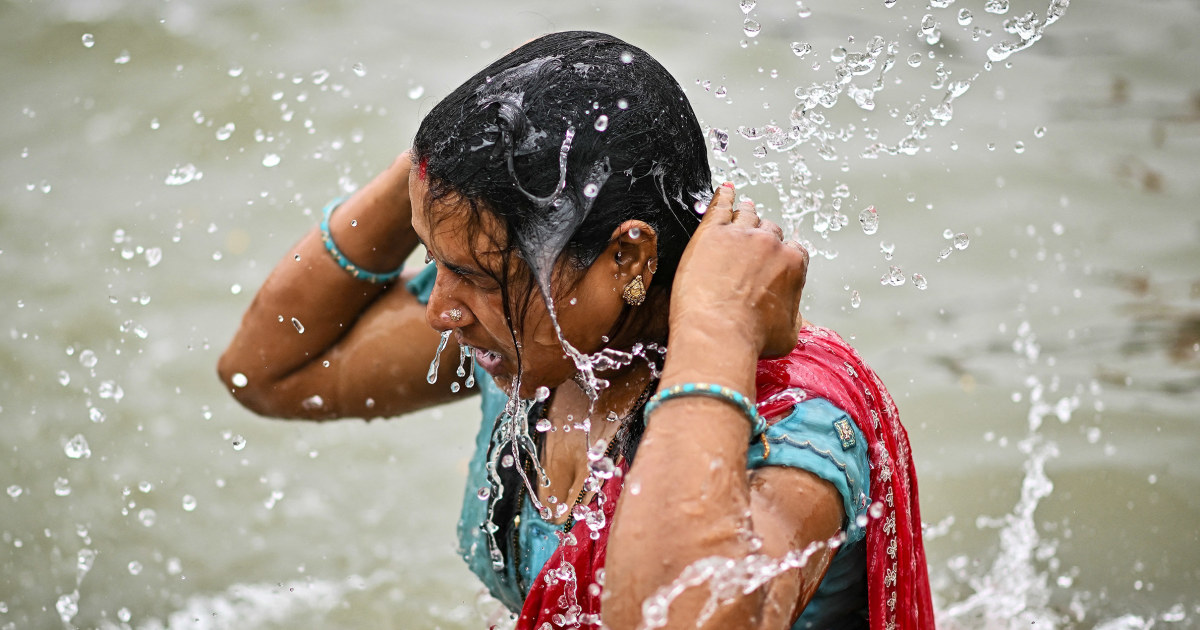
[517,326,934,630]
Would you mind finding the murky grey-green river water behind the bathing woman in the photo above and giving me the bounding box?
[0,0,1200,630]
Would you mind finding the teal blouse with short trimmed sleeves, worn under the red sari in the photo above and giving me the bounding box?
[408,265,870,630]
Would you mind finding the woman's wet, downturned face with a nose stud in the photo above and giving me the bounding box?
[409,174,653,397]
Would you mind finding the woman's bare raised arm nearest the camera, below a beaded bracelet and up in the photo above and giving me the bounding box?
[604,186,844,630]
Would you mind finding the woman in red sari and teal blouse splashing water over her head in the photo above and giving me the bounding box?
[220,32,934,630]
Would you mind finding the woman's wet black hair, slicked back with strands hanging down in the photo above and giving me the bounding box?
[413,31,712,578]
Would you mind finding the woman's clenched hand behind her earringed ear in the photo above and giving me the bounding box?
[671,184,809,358]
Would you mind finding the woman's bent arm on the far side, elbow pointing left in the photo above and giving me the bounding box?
[217,154,474,420]
